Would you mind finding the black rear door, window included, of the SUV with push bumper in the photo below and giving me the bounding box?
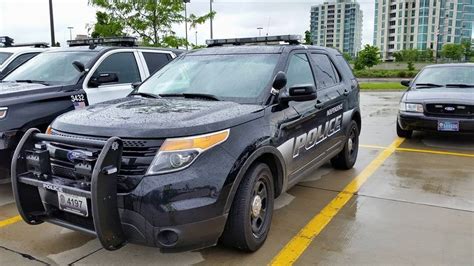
[311,51,347,153]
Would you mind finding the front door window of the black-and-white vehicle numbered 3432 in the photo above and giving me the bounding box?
[92,52,141,83]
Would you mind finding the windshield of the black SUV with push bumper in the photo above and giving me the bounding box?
[138,54,279,103]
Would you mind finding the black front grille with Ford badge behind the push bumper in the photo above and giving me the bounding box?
[48,131,163,188]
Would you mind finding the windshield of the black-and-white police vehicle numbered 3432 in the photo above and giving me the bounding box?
[3,52,96,85]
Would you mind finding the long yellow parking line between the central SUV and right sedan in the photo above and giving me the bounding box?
[270,138,404,265]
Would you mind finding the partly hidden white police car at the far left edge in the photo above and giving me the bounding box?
[0,36,49,80]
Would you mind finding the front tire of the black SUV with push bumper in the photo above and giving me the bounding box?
[221,163,274,252]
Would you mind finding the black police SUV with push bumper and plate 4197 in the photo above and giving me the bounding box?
[12,35,361,251]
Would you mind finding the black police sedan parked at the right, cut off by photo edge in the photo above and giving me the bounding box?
[397,63,474,138]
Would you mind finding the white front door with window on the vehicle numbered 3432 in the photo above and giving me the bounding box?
[83,49,143,104]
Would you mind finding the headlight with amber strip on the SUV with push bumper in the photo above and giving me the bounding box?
[147,129,229,175]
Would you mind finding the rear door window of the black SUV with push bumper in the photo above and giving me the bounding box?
[311,54,339,89]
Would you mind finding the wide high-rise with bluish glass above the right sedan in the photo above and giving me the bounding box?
[374,0,474,61]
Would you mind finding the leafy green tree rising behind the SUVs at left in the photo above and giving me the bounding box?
[89,0,215,47]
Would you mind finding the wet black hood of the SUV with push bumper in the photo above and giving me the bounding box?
[52,97,263,138]
